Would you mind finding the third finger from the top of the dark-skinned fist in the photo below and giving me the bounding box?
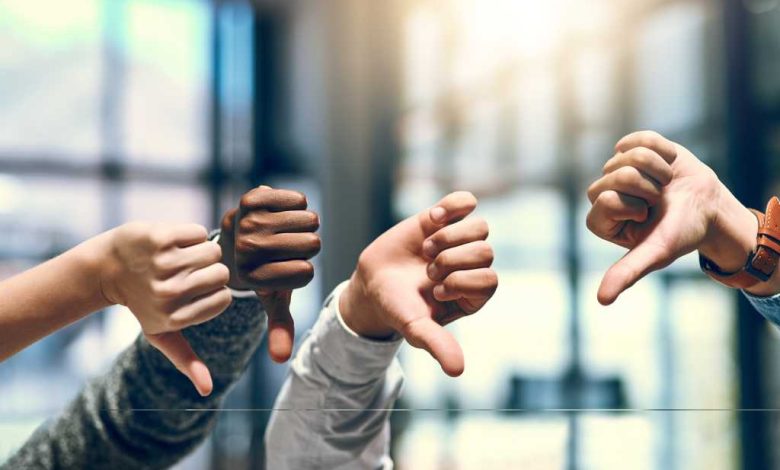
[236,232,322,264]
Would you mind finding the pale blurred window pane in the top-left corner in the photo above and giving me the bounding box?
[0,0,102,162]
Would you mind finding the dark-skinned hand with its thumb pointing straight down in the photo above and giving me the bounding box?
[220,186,320,362]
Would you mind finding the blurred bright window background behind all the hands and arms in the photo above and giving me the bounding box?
[0,0,780,470]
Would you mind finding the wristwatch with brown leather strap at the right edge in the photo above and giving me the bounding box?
[699,197,780,289]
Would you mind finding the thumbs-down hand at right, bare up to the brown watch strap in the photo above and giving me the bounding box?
[587,131,758,305]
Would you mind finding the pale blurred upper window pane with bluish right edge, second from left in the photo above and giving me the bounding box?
[123,0,210,168]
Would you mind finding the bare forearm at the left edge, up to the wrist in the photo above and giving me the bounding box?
[0,232,112,361]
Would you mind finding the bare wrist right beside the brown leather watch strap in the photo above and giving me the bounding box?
[699,184,758,272]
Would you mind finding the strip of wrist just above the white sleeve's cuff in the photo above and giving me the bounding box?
[338,273,395,340]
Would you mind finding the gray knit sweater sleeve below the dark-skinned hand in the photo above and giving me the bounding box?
[2,299,266,469]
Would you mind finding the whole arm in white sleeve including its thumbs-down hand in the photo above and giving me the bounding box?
[266,193,498,469]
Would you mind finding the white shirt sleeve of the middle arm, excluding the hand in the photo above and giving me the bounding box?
[265,283,403,470]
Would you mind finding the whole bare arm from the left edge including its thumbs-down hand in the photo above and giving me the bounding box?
[0,222,230,395]
